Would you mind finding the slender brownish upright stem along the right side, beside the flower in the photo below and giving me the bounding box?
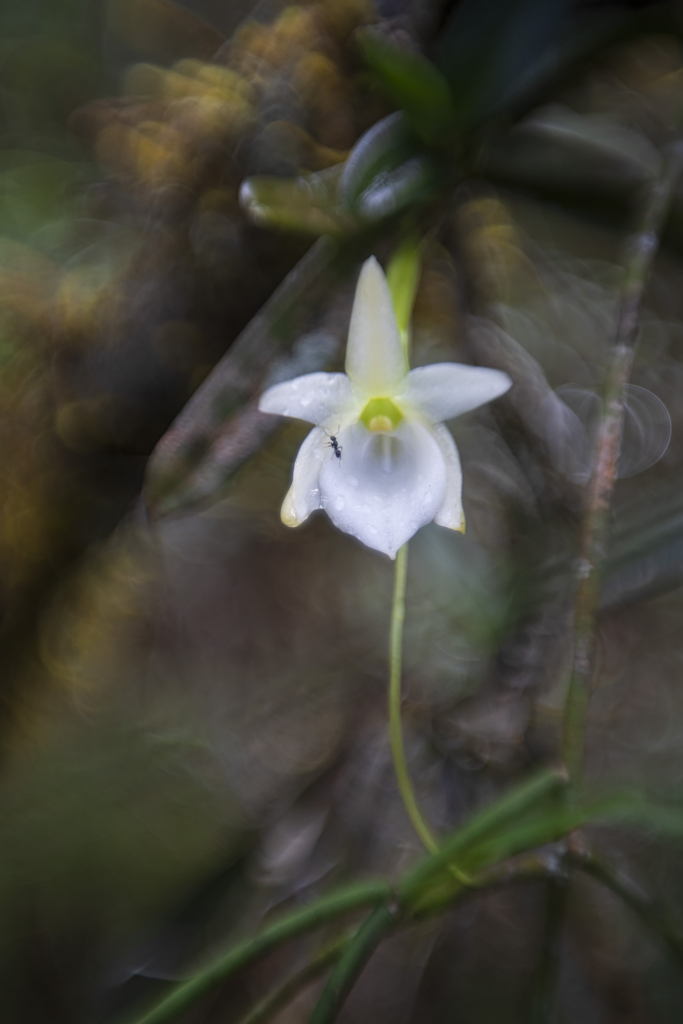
[563,143,683,790]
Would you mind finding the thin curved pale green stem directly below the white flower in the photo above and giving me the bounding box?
[389,544,438,853]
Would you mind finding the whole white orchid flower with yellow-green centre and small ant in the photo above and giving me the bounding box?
[259,257,512,558]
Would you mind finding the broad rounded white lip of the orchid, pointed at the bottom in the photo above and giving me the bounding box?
[319,421,447,558]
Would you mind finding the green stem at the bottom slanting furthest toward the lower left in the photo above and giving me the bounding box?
[122,882,392,1024]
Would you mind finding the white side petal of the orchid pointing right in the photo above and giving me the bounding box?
[395,362,512,423]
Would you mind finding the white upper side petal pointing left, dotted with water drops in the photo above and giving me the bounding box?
[258,373,354,426]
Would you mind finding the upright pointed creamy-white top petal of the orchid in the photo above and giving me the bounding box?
[346,256,408,397]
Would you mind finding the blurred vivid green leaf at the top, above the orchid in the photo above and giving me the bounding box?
[359,31,456,148]
